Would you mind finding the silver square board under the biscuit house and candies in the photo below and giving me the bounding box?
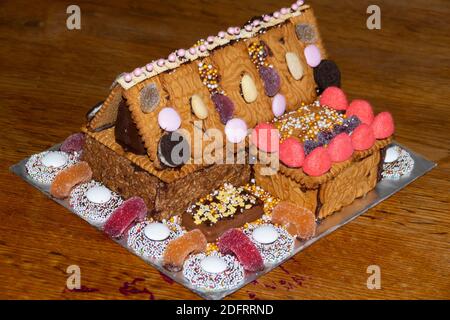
[10,142,436,300]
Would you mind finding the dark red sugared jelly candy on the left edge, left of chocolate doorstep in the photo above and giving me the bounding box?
[104,197,147,238]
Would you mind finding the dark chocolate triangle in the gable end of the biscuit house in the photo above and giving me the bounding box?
[114,99,147,155]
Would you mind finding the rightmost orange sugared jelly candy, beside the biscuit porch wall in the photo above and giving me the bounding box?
[272,201,316,240]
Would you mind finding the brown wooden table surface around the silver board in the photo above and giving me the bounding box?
[0,0,450,299]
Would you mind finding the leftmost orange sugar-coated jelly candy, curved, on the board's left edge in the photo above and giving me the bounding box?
[50,161,92,199]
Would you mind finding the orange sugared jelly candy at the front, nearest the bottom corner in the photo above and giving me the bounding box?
[163,229,208,272]
